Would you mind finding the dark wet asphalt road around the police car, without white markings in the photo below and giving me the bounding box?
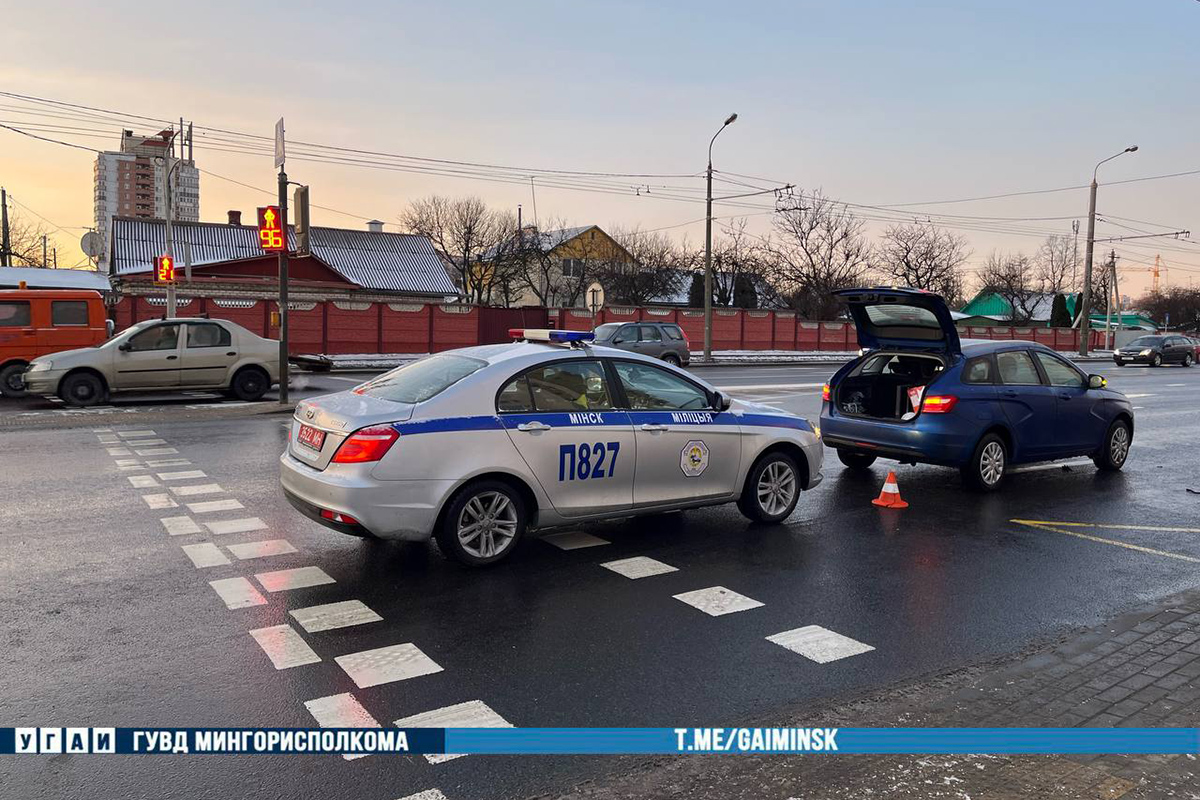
[0,365,1200,800]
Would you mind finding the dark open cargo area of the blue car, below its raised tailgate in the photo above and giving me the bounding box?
[832,353,946,422]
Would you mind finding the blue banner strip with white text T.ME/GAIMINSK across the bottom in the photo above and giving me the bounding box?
[0,727,1200,756]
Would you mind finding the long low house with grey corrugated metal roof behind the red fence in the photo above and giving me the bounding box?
[109,213,458,300]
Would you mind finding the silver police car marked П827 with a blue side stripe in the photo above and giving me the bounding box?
[280,330,822,566]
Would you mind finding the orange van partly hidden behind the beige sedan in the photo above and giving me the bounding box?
[0,289,112,397]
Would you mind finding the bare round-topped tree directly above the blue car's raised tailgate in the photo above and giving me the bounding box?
[878,222,971,306]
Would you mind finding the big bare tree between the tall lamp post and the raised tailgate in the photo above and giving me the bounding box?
[764,191,872,319]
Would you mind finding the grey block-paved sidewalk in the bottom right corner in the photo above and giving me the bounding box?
[547,591,1200,800]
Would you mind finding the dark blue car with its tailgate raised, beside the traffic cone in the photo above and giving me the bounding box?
[821,288,1134,491]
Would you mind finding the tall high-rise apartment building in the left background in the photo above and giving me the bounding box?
[95,125,200,269]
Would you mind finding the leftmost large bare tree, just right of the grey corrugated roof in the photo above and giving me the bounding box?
[400,194,501,303]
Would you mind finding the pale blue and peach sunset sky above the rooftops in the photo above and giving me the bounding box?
[0,0,1200,295]
